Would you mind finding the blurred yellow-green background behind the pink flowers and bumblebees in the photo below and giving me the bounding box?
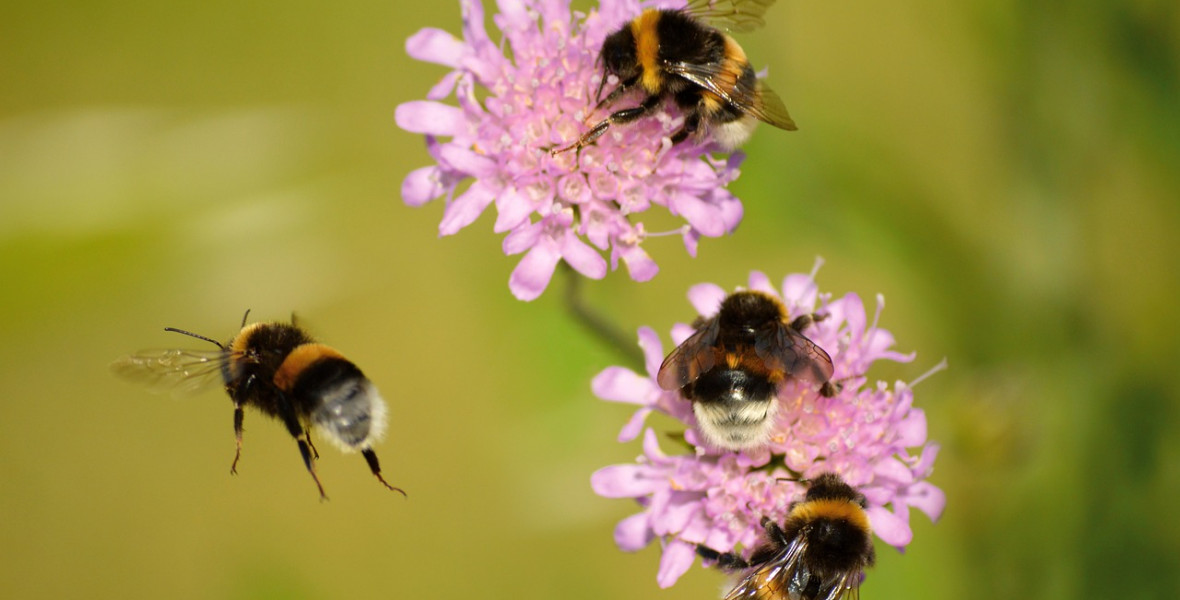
[0,0,1180,600]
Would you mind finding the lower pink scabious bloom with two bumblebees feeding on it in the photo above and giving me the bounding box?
[590,265,946,587]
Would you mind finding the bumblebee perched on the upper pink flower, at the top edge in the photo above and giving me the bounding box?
[551,0,795,155]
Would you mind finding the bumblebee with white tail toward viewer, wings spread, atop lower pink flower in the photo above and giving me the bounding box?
[656,291,835,450]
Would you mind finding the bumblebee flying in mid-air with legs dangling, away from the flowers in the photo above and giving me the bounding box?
[111,311,406,500]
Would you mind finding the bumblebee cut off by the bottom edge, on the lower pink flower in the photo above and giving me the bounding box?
[696,472,876,600]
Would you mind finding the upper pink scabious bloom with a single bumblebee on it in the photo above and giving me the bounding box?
[395,0,743,300]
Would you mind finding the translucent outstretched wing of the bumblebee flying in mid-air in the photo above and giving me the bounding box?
[111,348,229,396]
